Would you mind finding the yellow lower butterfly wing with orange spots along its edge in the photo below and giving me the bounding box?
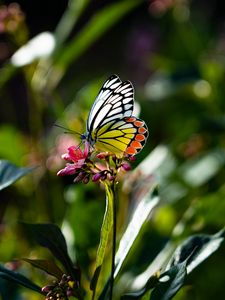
[95,116,148,157]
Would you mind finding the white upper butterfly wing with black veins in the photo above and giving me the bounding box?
[86,75,134,144]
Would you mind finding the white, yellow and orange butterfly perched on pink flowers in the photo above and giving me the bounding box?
[81,75,148,157]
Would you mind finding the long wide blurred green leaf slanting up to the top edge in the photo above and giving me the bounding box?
[39,0,143,89]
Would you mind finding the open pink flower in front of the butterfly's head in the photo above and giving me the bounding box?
[57,142,89,176]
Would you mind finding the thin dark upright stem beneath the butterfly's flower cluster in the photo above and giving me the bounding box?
[109,182,116,300]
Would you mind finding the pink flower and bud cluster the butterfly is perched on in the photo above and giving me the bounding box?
[57,142,131,184]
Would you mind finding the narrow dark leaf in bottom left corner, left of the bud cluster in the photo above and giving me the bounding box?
[0,265,42,294]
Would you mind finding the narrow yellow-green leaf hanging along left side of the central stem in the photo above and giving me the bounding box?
[90,182,115,290]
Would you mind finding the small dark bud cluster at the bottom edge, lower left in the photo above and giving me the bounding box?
[42,274,78,300]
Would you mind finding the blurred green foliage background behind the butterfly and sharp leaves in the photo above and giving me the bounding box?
[0,0,225,300]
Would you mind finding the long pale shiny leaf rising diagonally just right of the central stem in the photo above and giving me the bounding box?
[114,186,159,277]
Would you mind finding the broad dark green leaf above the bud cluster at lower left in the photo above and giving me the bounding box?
[23,223,78,279]
